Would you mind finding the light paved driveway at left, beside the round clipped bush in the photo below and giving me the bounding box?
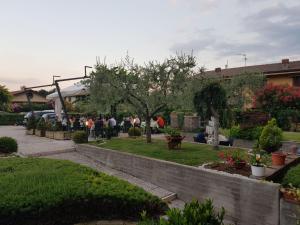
[0,126,74,156]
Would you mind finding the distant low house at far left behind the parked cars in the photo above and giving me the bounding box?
[10,90,48,105]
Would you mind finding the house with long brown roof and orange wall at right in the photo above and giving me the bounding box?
[203,59,300,87]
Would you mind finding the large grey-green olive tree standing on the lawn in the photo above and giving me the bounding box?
[88,55,195,143]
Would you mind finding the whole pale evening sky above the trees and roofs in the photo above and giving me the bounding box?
[0,0,300,90]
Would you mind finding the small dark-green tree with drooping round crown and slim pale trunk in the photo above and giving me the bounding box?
[194,82,227,148]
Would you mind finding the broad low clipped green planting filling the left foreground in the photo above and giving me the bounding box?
[0,158,166,225]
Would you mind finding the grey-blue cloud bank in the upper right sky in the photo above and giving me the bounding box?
[170,4,300,58]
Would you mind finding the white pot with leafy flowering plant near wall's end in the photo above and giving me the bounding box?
[250,151,270,177]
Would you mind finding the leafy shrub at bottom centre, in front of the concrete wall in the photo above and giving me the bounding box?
[139,199,225,225]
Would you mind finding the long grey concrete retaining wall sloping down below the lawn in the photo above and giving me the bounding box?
[77,145,279,225]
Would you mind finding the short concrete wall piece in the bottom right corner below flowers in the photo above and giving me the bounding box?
[280,199,300,225]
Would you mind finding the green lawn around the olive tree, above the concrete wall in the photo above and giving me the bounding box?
[92,138,229,166]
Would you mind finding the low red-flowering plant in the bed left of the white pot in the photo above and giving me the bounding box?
[219,149,247,169]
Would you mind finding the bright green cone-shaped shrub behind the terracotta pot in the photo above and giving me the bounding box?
[259,118,282,153]
